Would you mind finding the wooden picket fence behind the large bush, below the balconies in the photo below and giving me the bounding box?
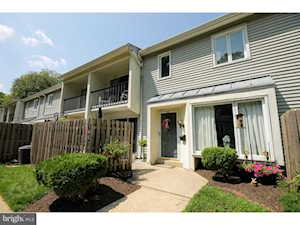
[31,119,134,171]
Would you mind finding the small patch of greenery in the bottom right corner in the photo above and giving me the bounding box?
[279,192,300,212]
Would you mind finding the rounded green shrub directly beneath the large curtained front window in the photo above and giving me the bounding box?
[201,147,237,174]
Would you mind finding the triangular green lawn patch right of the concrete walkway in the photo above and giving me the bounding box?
[184,186,267,212]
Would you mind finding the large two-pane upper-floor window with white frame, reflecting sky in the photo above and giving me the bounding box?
[212,26,250,66]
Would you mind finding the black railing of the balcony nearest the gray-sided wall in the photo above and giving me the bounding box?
[91,81,128,109]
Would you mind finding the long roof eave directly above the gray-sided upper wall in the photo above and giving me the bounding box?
[140,13,254,56]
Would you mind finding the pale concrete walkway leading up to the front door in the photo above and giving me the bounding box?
[100,161,207,212]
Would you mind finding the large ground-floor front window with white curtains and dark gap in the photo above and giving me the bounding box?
[193,99,274,161]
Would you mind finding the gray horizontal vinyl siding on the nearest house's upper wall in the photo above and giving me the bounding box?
[142,14,300,135]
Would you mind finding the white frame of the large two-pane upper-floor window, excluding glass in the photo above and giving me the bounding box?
[211,24,251,67]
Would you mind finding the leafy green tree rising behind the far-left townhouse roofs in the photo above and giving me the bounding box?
[11,70,59,98]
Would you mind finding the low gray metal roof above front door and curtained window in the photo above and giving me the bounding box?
[147,76,274,103]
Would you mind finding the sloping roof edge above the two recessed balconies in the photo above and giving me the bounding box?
[60,43,139,80]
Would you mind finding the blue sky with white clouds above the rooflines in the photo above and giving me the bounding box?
[0,13,224,93]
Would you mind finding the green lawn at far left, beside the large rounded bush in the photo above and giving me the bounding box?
[0,165,48,211]
